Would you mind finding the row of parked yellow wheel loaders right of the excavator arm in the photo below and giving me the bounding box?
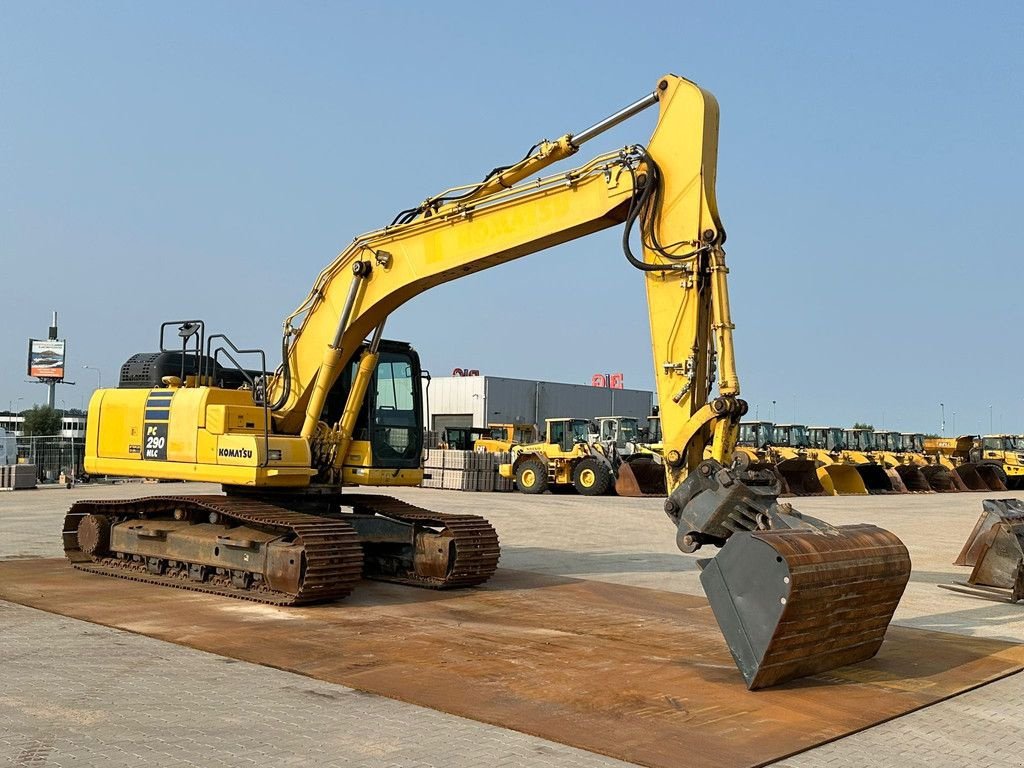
[738,421,1024,496]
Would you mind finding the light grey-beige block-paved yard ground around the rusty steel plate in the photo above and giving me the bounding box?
[0,484,1024,768]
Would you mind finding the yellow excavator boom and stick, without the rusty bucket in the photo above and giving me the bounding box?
[271,76,733,487]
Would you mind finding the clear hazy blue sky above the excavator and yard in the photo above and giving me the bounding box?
[0,1,1024,432]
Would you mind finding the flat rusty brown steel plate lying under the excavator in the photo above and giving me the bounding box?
[0,560,1024,768]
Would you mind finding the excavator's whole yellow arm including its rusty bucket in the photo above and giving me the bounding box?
[258,76,909,688]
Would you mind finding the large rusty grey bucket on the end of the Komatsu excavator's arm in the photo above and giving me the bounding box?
[700,525,910,690]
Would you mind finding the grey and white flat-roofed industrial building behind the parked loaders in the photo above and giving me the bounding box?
[423,376,653,431]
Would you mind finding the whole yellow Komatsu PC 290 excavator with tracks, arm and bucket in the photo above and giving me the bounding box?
[63,75,910,689]
